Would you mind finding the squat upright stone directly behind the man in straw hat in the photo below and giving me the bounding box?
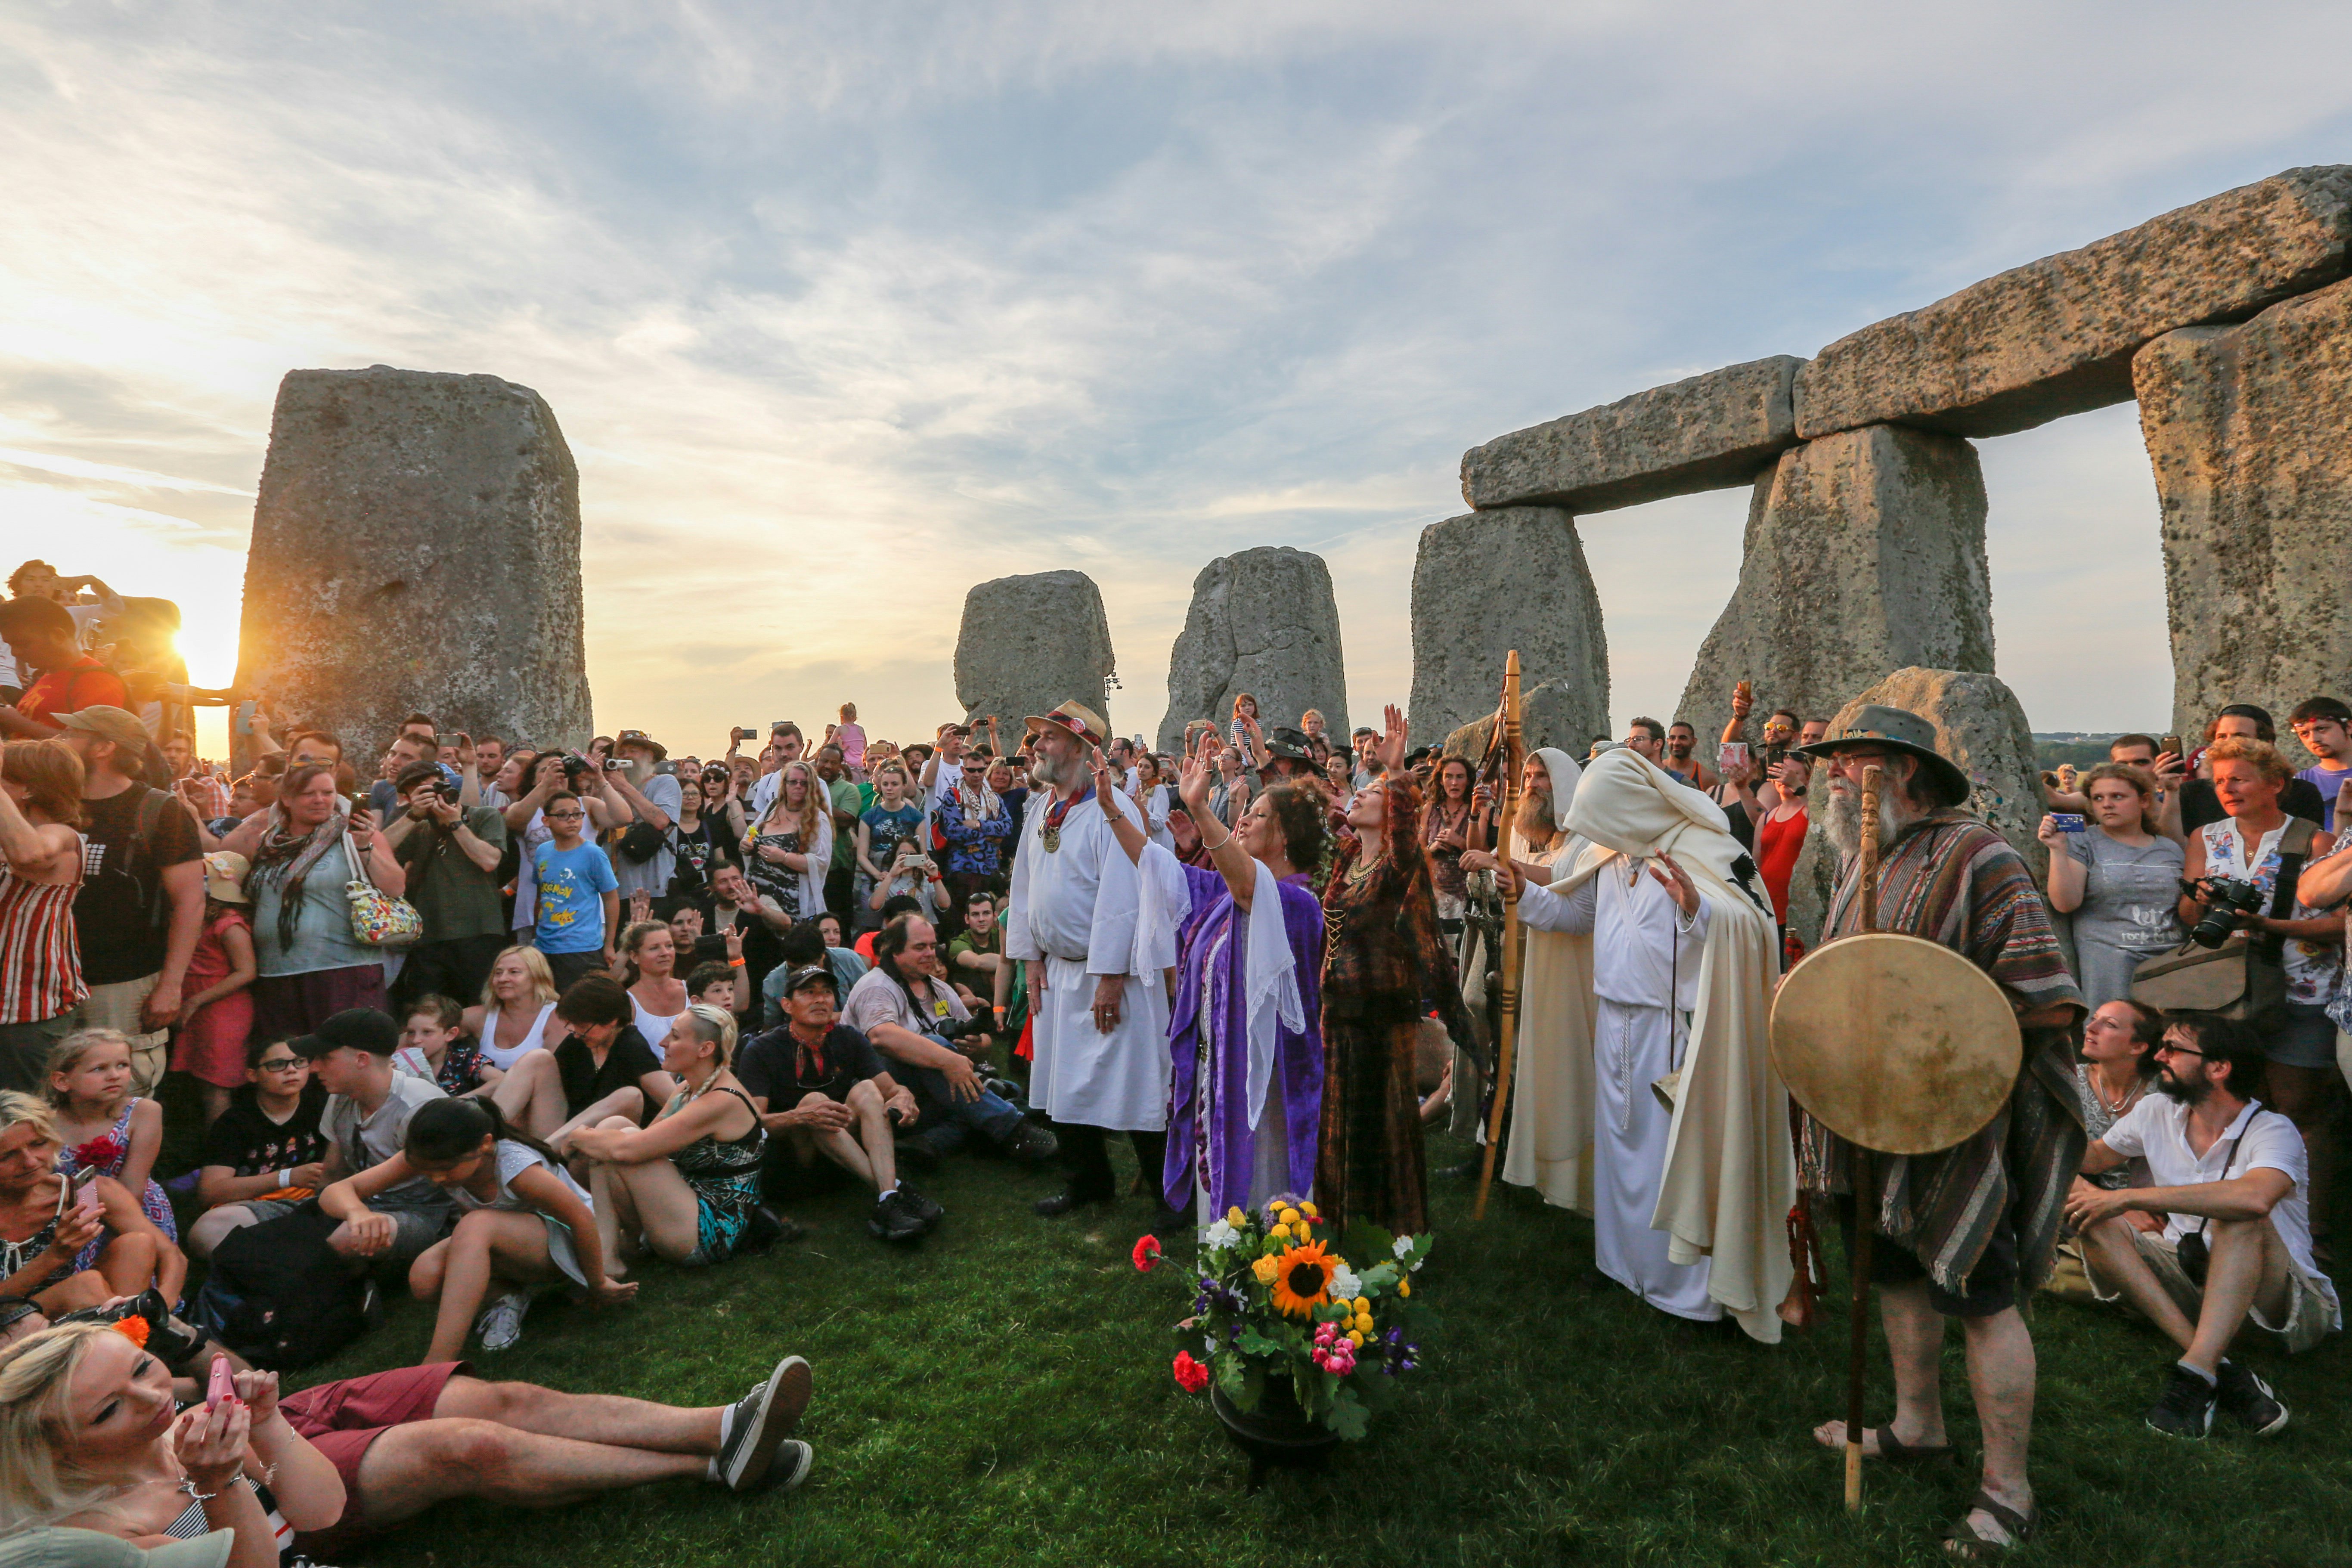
[955,571,1117,745]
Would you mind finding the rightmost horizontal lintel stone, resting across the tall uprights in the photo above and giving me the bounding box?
[1797,164,2352,437]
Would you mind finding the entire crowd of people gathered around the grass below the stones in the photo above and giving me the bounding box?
[0,562,2352,1563]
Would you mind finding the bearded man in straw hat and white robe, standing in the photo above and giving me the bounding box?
[995,700,1181,1225]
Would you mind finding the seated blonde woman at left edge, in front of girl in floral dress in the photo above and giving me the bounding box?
[0,1088,171,1312]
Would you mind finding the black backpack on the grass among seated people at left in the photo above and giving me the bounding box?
[195,1199,372,1373]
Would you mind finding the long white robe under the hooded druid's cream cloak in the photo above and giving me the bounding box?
[1519,858,1724,1321]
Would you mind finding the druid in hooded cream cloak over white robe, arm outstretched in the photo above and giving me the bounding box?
[1519,750,1797,1342]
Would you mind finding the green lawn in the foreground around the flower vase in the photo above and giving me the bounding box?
[289,1143,2352,1568]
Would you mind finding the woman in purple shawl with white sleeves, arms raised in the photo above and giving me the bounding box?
[1096,734,1326,1225]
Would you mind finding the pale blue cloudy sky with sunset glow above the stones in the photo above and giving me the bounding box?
[0,0,2352,752]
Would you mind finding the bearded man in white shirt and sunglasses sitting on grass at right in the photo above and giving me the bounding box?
[2065,1013,2343,1436]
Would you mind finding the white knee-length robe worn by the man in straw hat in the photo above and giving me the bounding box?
[1004,790,1169,1133]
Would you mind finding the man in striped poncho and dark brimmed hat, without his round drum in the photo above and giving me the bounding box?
[1797,705,2084,1552]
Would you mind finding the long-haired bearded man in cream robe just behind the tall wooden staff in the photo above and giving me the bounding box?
[1479,745,1592,1213]
